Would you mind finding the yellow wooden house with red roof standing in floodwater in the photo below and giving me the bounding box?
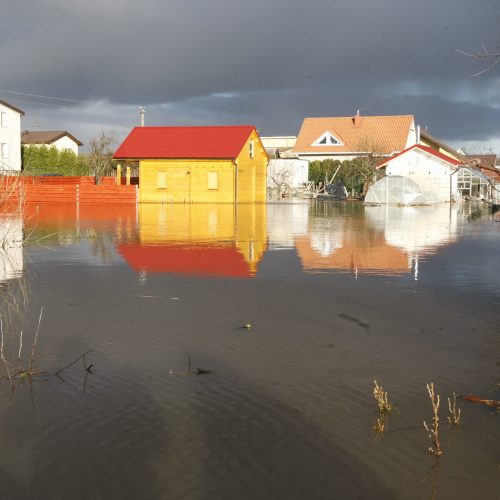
[114,125,269,203]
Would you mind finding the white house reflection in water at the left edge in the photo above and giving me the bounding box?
[0,214,24,283]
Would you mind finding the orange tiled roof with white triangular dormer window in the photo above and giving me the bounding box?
[293,113,417,160]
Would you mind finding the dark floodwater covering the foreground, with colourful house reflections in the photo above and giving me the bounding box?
[0,202,500,500]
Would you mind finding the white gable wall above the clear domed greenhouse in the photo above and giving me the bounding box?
[386,149,457,202]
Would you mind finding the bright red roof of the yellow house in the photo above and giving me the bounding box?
[113,125,255,159]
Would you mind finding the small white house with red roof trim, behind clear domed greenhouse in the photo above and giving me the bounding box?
[372,144,463,204]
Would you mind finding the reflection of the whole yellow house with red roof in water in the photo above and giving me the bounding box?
[118,204,267,277]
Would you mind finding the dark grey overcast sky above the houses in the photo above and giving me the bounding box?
[0,0,500,154]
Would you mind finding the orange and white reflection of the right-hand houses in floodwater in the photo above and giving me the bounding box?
[295,201,457,279]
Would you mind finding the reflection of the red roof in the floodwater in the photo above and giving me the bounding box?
[117,243,253,278]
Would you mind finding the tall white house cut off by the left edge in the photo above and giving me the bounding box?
[0,101,24,173]
